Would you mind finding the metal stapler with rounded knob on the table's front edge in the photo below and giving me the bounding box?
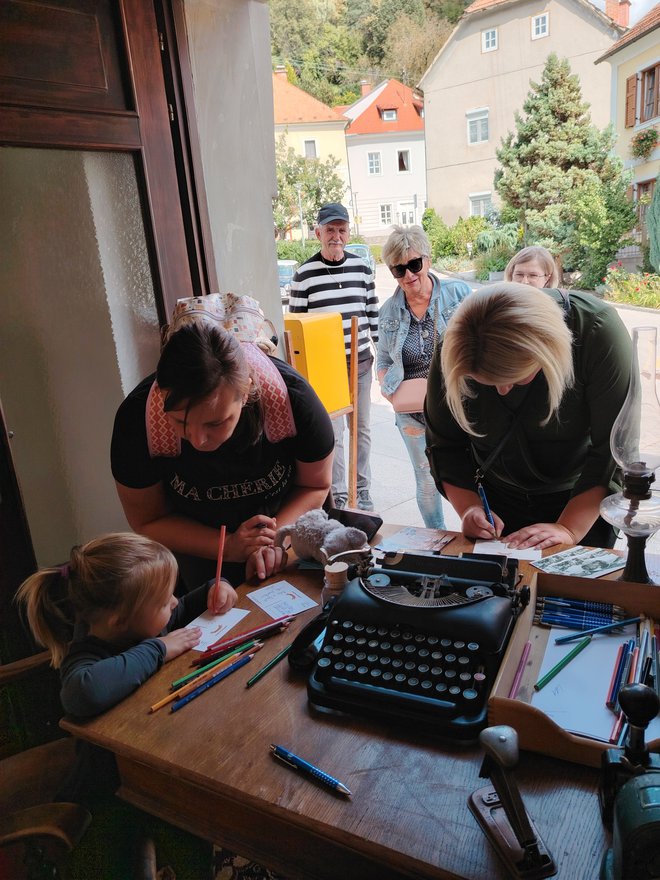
[468,724,557,880]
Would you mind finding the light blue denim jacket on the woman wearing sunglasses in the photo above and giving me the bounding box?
[376,272,470,394]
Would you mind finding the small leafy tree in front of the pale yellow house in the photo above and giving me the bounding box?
[273,134,346,238]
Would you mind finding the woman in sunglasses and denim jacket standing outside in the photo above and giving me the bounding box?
[376,226,470,529]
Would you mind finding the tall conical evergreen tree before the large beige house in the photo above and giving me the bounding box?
[495,53,634,286]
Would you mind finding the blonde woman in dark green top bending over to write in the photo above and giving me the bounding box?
[425,283,631,550]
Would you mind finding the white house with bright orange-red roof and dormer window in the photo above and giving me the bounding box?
[335,79,426,241]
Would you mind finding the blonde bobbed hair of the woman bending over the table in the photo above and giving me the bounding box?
[440,282,573,436]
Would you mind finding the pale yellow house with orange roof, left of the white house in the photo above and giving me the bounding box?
[273,65,350,234]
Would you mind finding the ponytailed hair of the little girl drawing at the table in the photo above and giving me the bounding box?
[16,532,178,668]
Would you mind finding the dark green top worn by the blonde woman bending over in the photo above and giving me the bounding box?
[425,290,631,495]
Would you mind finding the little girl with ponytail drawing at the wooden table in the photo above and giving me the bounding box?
[16,532,228,718]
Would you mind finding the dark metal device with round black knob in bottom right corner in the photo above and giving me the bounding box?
[599,684,660,880]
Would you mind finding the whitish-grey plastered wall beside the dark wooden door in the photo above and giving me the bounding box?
[185,0,282,332]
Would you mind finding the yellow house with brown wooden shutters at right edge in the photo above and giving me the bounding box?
[596,3,660,248]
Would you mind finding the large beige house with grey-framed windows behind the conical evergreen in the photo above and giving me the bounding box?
[420,0,631,223]
